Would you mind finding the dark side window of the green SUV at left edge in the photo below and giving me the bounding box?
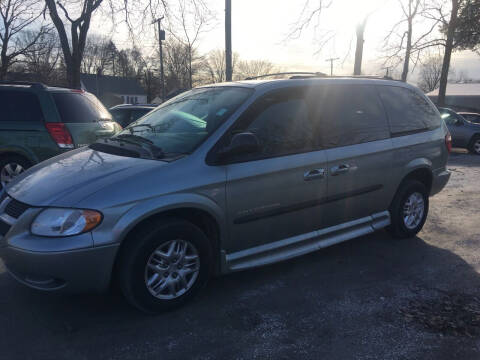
[0,91,44,122]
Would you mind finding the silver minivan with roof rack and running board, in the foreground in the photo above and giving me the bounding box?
[0,77,451,313]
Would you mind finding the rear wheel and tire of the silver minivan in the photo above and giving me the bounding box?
[387,180,429,239]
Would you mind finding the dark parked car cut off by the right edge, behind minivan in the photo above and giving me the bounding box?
[438,107,480,155]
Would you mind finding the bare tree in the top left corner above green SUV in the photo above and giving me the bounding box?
[0,0,47,79]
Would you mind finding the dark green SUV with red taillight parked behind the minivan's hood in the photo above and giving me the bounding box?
[0,82,121,189]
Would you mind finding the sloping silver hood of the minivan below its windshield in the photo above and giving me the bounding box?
[6,147,168,206]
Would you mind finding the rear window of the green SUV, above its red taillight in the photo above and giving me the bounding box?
[52,92,112,123]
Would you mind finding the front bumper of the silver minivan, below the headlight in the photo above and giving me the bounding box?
[0,239,118,293]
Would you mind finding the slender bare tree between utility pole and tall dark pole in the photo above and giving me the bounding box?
[168,0,214,88]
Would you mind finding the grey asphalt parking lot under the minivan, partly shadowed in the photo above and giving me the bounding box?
[0,151,480,360]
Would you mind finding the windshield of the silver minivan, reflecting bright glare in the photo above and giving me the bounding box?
[116,86,253,154]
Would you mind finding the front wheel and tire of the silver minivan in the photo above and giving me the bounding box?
[118,218,213,313]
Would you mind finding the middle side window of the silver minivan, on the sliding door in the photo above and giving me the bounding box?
[311,84,390,148]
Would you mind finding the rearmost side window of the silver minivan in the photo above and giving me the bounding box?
[378,86,440,136]
